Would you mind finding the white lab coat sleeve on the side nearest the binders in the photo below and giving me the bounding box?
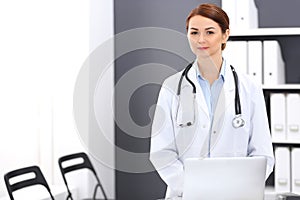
[248,86,274,179]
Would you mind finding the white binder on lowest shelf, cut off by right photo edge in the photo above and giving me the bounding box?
[291,148,300,194]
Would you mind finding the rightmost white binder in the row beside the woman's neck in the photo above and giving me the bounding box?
[263,40,285,85]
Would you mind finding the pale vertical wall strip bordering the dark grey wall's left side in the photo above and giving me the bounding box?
[88,0,115,198]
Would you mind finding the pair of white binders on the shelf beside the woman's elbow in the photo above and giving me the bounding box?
[270,93,300,143]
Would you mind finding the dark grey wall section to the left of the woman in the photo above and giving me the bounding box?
[115,0,220,200]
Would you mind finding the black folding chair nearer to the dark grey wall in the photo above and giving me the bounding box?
[58,152,107,200]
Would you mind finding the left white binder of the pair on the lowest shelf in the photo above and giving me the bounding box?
[274,147,291,193]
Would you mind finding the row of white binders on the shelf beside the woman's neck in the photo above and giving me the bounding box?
[223,40,285,85]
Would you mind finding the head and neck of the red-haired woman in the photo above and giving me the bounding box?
[186,4,229,84]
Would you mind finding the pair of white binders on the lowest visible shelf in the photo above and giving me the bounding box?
[274,147,300,194]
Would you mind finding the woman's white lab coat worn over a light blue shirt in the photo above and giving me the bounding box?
[150,62,274,198]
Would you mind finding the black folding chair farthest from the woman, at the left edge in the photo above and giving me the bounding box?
[4,166,54,200]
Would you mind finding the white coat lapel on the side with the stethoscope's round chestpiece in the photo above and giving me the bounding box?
[213,65,235,127]
